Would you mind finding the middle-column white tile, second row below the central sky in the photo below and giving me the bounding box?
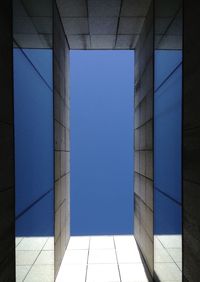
[88,249,117,264]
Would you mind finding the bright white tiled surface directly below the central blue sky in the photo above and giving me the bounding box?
[56,235,148,282]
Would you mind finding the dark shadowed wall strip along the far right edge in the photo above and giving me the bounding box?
[183,1,200,282]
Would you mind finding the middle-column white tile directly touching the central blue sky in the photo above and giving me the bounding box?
[90,236,114,249]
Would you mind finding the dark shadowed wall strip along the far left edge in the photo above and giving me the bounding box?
[0,0,15,281]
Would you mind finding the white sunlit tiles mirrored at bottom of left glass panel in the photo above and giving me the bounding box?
[16,237,54,282]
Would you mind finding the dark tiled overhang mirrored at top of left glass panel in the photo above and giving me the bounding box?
[13,0,52,48]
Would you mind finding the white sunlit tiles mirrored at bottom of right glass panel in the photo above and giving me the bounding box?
[154,235,182,282]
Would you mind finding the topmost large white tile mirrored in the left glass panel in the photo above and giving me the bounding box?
[16,237,47,251]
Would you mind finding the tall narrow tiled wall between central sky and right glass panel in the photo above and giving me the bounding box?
[134,0,154,275]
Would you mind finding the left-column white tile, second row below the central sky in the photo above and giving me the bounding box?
[63,250,88,265]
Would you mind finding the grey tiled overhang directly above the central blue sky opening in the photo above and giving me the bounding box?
[57,0,150,50]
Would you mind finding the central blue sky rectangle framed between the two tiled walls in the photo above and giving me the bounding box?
[70,51,134,235]
